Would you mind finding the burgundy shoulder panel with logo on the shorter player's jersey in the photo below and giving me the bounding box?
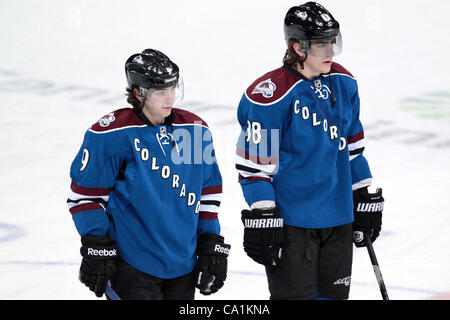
[90,108,145,133]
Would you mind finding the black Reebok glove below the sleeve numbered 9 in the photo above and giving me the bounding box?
[79,234,118,297]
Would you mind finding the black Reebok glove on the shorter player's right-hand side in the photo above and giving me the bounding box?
[195,233,231,295]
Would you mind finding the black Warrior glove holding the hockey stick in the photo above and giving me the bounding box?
[353,187,384,248]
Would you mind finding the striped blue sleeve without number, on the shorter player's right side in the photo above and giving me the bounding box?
[197,129,222,236]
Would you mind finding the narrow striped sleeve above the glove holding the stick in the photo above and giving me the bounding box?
[347,88,372,190]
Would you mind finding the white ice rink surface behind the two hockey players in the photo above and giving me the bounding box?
[0,0,450,300]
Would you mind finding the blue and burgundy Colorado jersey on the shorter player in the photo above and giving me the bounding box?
[67,108,222,278]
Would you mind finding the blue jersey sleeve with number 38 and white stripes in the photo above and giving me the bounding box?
[235,94,287,207]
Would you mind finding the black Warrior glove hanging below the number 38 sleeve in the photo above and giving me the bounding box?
[241,207,284,268]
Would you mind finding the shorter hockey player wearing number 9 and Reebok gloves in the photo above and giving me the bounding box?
[67,49,230,300]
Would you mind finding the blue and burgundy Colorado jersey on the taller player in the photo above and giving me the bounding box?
[236,63,372,228]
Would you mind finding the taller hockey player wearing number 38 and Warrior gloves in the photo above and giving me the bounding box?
[236,2,384,299]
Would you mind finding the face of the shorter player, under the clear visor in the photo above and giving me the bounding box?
[142,86,175,124]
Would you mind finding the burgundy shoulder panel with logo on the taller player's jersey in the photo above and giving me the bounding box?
[245,67,302,105]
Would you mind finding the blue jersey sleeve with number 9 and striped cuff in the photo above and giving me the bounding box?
[67,130,123,235]
